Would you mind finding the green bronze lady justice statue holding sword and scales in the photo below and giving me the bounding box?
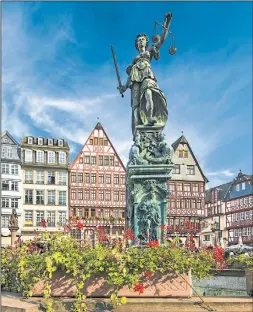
[111,13,176,136]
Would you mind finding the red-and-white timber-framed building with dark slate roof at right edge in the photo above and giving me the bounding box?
[225,171,253,246]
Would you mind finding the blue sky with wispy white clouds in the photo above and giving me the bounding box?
[2,2,252,186]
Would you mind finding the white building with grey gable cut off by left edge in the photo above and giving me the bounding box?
[1,131,22,246]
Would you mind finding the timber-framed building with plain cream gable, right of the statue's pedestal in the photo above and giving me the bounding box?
[168,135,208,246]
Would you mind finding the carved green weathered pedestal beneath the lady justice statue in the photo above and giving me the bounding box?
[127,126,173,245]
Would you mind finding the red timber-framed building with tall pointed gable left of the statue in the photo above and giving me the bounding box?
[69,122,126,239]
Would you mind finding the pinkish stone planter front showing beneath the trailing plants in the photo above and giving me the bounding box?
[33,271,192,298]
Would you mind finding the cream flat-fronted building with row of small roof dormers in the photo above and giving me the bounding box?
[21,136,69,240]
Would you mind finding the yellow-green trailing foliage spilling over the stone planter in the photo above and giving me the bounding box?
[1,234,216,312]
